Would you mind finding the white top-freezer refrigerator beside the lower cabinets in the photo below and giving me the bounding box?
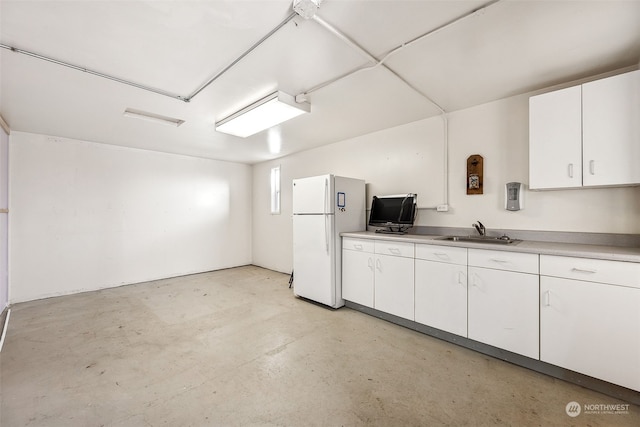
[293,175,366,308]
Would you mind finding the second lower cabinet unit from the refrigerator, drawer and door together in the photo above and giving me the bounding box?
[374,240,415,320]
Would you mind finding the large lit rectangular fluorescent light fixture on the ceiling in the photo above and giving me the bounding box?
[216,91,311,138]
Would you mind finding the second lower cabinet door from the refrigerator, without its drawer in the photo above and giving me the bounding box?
[374,255,414,320]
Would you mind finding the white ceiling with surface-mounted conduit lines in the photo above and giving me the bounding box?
[0,0,640,163]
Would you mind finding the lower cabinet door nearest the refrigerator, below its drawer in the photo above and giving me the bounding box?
[342,250,374,308]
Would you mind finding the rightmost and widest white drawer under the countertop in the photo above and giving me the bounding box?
[540,255,640,288]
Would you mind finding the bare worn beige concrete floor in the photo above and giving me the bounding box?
[0,266,640,427]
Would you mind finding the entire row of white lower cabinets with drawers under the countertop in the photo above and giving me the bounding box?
[342,237,640,391]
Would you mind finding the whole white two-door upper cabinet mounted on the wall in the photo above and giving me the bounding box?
[529,71,640,189]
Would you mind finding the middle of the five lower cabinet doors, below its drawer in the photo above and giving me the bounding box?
[415,259,467,337]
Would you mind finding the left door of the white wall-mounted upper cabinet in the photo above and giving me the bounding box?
[529,86,582,189]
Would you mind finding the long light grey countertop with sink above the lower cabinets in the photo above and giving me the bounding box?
[340,231,640,263]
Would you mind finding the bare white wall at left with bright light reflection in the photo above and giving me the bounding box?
[9,132,252,303]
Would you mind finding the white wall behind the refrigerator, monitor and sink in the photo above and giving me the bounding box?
[253,95,640,272]
